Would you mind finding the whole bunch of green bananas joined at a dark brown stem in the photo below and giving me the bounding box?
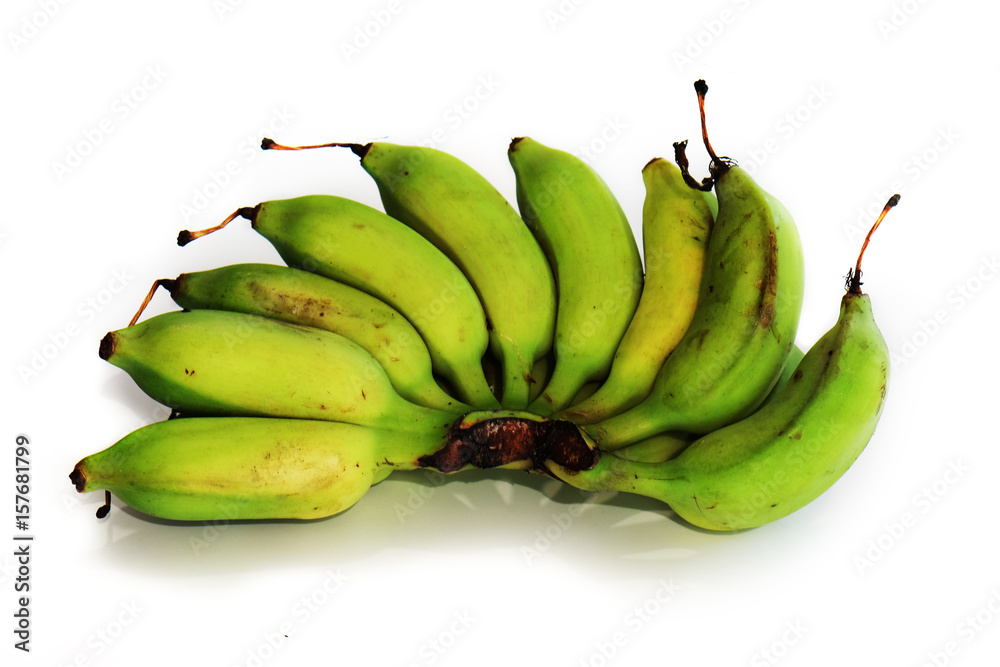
[70,81,896,531]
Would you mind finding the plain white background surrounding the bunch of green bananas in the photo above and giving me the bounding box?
[0,0,1000,667]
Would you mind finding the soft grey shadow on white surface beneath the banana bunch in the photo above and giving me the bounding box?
[82,469,741,578]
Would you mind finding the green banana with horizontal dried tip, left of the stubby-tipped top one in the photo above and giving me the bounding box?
[348,142,556,410]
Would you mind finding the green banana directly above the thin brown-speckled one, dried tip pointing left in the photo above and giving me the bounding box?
[178,195,499,408]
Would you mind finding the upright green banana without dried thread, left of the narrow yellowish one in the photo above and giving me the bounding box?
[507,137,642,415]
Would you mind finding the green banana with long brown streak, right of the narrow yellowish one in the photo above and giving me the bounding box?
[584,166,804,451]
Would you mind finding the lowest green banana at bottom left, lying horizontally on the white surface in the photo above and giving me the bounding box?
[70,417,446,521]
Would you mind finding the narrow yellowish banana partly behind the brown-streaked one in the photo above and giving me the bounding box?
[559,158,718,424]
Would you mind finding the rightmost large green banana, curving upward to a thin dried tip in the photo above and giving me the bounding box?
[549,293,889,531]
